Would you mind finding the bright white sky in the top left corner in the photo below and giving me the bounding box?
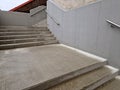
[0,0,28,11]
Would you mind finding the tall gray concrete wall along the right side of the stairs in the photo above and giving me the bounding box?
[47,0,120,68]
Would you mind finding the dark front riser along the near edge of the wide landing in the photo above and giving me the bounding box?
[23,61,106,90]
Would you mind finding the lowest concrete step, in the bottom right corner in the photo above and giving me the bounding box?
[96,76,120,90]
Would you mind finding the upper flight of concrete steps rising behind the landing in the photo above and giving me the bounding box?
[0,26,58,50]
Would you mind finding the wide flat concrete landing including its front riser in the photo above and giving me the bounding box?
[0,44,106,90]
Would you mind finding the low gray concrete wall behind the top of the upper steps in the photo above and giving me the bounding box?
[0,5,46,26]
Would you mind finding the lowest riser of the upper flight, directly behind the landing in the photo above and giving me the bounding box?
[0,41,58,50]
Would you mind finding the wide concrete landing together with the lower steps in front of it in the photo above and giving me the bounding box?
[0,36,120,90]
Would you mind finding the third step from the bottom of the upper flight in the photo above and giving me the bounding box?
[0,34,53,40]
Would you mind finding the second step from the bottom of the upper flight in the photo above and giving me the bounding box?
[0,37,56,45]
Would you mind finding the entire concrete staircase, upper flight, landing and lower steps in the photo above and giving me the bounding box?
[0,26,120,90]
